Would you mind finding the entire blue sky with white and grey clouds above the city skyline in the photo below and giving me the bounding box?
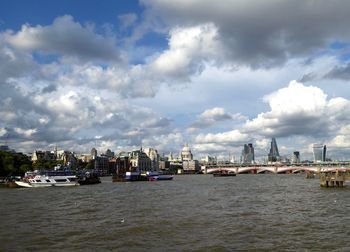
[0,0,350,160]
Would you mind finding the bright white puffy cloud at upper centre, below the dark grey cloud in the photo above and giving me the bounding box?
[150,23,223,80]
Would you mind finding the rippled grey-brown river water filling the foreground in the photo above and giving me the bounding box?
[0,174,350,251]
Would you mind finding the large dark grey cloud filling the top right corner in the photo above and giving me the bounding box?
[142,0,350,68]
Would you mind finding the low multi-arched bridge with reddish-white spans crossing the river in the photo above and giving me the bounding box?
[201,162,350,174]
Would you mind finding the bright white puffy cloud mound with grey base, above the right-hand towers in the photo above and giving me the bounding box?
[243,81,350,137]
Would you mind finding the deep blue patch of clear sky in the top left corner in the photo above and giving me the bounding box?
[0,0,143,30]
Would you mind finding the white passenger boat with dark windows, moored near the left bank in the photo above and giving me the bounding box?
[15,171,79,187]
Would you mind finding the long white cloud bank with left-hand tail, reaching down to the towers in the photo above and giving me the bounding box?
[189,81,350,158]
